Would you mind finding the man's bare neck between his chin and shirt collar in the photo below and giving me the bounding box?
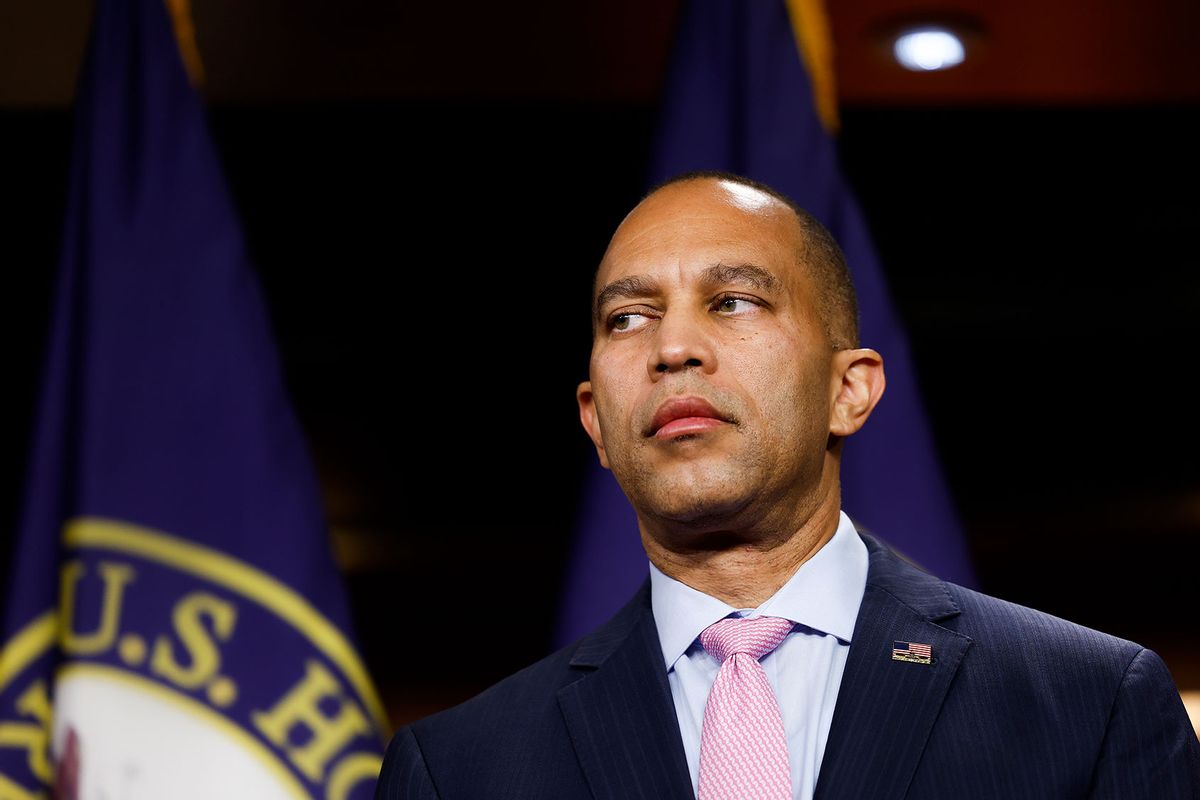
[641,493,840,608]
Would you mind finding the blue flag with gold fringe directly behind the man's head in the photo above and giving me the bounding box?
[557,0,974,643]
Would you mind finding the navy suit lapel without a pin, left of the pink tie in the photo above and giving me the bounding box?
[558,582,692,800]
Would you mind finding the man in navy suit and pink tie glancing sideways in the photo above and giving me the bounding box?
[377,174,1200,800]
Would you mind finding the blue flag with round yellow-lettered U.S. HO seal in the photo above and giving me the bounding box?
[0,0,390,800]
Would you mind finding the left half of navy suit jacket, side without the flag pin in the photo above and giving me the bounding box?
[376,583,691,800]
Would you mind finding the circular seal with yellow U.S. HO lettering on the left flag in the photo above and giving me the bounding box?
[0,518,388,800]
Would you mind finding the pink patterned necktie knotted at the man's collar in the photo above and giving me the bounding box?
[700,616,792,800]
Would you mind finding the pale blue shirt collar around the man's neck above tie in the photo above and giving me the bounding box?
[650,512,868,672]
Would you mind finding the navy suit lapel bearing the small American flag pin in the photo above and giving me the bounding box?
[815,536,971,800]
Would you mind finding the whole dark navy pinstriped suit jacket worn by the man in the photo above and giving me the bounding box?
[376,536,1200,800]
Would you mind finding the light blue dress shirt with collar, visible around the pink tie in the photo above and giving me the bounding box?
[650,512,866,800]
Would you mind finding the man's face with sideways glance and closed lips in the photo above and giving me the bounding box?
[578,179,840,530]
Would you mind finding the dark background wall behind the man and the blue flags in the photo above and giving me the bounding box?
[0,2,1200,722]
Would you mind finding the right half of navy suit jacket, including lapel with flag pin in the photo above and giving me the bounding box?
[817,536,1200,799]
